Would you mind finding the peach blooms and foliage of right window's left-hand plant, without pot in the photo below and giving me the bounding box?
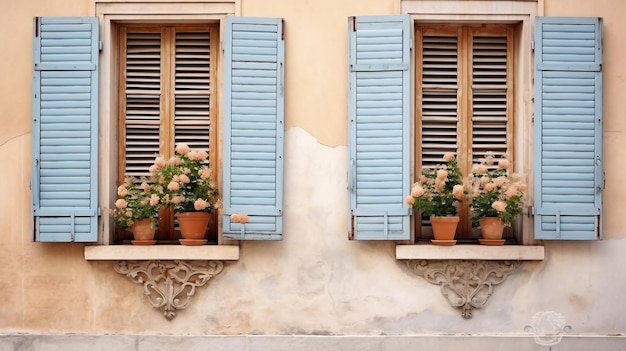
[405,152,465,216]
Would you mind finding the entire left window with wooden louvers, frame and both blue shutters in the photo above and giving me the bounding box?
[32,11,285,244]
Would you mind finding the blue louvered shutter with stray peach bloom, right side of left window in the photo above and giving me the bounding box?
[222,17,285,240]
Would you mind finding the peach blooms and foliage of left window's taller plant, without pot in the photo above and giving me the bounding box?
[150,144,220,213]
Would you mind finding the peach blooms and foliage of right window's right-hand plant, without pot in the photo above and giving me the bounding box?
[469,153,526,226]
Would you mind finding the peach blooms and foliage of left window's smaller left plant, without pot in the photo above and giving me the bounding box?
[112,177,162,229]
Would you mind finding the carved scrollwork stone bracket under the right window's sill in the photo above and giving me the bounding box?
[406,260,521,318]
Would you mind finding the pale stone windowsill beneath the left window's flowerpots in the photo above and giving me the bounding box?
[85,245,239,261]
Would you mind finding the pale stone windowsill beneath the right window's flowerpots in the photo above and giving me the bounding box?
[396,244,545,261]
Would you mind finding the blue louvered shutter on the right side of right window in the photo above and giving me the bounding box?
[534,17,603,240]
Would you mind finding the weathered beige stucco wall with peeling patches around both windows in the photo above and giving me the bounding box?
[0,0,626,342]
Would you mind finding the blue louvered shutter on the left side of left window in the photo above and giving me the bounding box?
[31,17,99,242]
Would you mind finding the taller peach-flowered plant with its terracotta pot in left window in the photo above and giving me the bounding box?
[150,144,220,245]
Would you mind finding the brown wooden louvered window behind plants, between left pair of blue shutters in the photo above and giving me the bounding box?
[117,24,219,242]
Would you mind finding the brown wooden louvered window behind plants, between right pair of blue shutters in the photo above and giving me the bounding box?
[414,24,515,238]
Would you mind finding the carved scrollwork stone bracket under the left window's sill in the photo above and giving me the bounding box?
[113,261,224,320]
